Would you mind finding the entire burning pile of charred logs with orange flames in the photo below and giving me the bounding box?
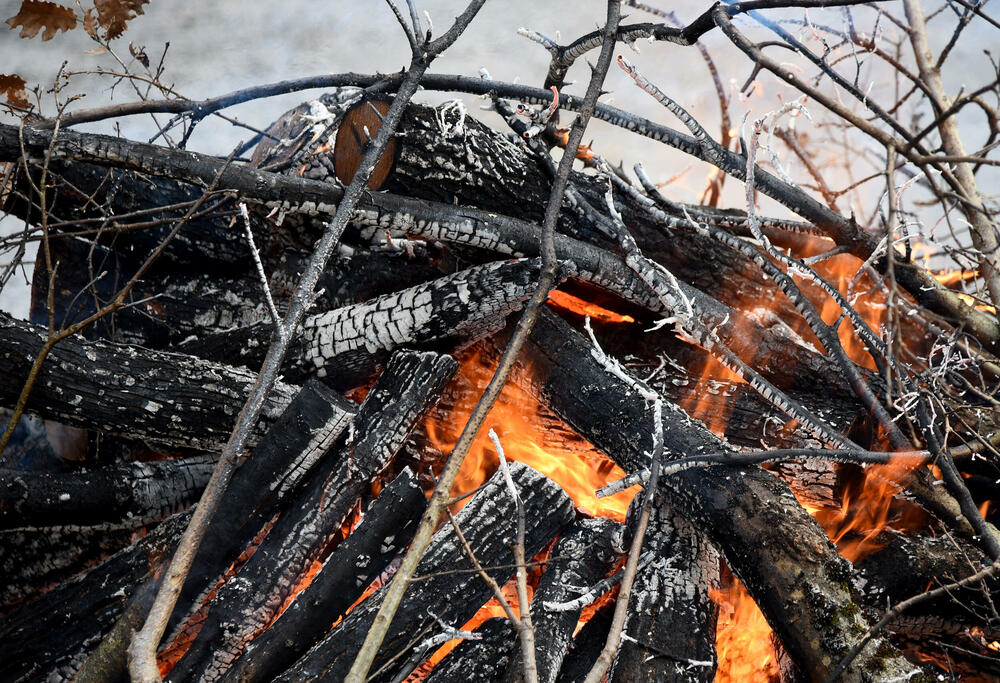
[0,2,1000,682]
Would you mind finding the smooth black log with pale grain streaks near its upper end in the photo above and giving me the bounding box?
[173,382,357,627]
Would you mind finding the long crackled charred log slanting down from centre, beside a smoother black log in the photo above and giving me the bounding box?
[169,351,458,681]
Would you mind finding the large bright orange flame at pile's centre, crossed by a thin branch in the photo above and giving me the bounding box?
[426,353,637,521]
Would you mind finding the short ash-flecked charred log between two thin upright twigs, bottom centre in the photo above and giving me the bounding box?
[504,518,622,683]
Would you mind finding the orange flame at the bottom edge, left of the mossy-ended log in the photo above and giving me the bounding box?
[709,578,779,683]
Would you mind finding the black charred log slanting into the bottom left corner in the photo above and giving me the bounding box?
[0,512,191,681]
